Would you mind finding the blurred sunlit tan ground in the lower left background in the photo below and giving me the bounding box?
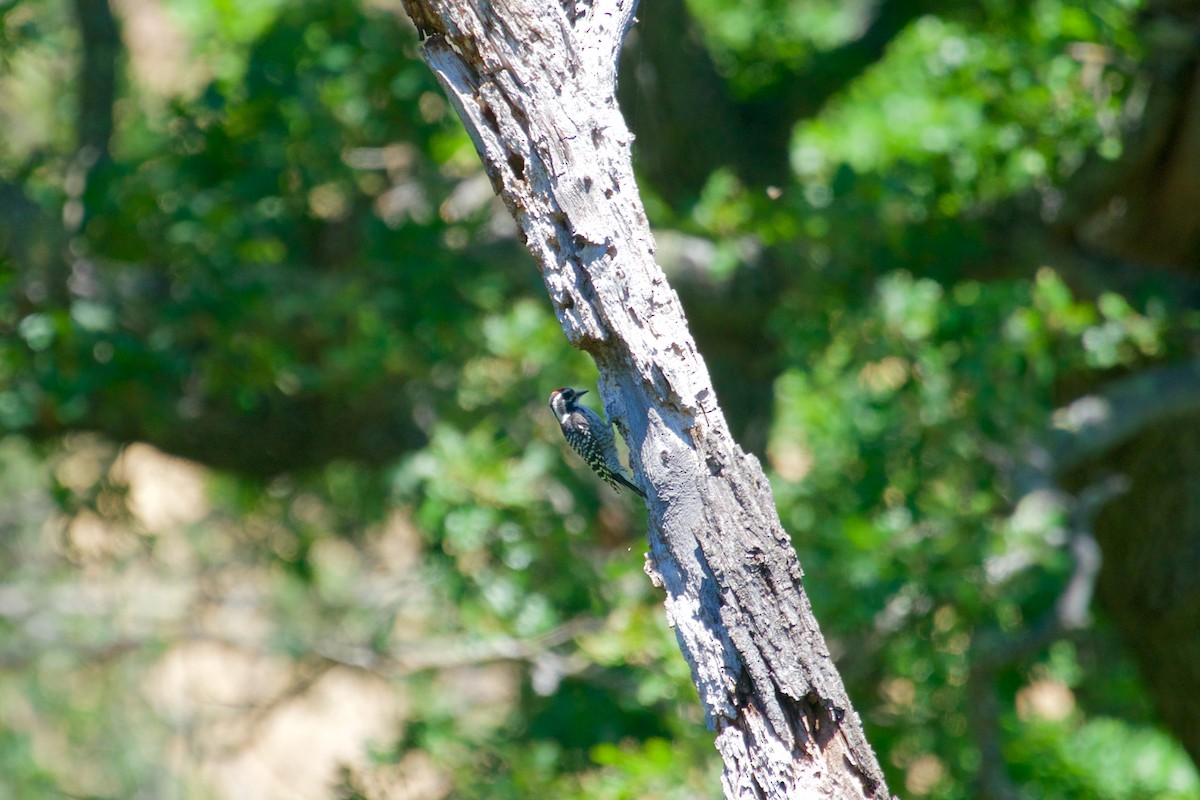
[0,437,501,800]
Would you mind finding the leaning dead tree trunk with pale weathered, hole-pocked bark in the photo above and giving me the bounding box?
[406,0,889,800]
